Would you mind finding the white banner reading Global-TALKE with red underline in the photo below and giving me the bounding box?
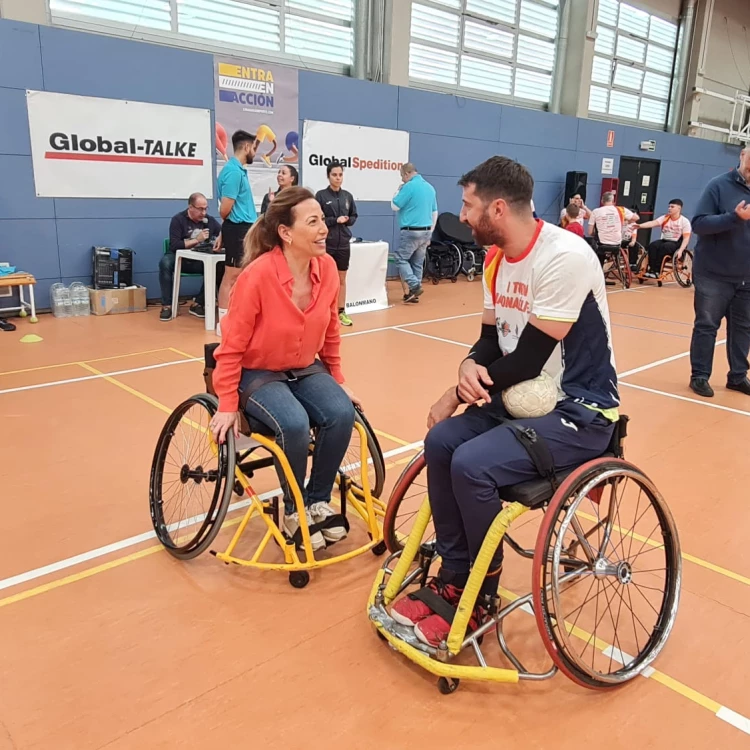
[26,91,213,199]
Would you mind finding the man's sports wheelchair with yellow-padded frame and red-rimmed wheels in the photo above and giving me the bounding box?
[368,417,682,693]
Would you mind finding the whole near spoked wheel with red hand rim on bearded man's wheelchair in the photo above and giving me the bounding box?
[532,458,682,689]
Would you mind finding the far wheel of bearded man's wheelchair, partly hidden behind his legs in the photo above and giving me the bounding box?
[383,451,435,553]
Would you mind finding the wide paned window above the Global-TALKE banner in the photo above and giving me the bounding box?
[49,0,354,70]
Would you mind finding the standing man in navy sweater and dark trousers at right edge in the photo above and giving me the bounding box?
[690,148,750,398]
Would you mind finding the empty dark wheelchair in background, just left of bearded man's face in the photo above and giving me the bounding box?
[424,212,485,284]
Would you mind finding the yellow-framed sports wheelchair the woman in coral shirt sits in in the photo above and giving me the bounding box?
[149,344,386,588]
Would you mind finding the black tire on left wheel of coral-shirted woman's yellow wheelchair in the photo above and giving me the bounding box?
[149,393,236,560]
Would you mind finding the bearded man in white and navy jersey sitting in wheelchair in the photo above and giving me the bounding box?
[391,156,619,646]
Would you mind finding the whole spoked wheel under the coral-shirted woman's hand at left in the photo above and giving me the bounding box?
[149,394,235,560]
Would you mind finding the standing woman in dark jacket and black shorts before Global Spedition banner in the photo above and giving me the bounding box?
[315,162,357,326]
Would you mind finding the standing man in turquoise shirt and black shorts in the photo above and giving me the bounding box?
[216,130,259,336]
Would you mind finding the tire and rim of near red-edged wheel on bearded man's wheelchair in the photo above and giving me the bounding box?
[532,458,682,689]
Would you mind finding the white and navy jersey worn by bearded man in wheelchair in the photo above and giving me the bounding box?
[483,220,620,421]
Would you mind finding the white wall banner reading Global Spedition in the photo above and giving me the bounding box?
[302,120,409,202]
